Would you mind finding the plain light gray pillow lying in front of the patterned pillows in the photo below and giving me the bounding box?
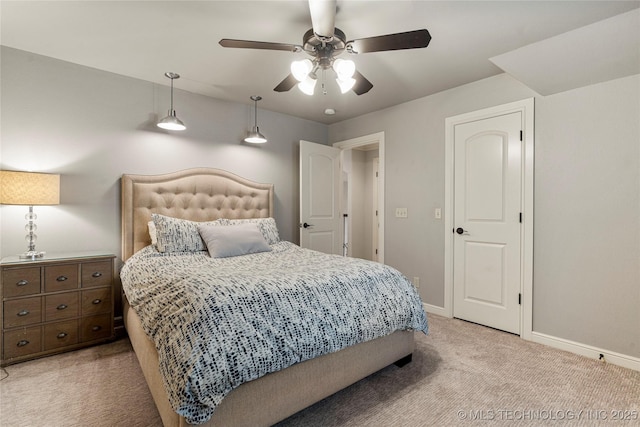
[198,223,271,258]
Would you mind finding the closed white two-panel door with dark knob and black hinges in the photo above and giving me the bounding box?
[452,112,522,334]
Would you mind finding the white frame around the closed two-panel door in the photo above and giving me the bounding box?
[439,98,534,340]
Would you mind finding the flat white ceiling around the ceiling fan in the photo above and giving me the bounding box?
[0,0,640,123]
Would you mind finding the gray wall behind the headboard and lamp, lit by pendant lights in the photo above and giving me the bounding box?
[0,47,328,256]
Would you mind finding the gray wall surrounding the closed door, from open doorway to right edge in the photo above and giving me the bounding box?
[329,74,640,357]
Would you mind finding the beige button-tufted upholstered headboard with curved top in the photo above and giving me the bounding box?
[121,168,273,262]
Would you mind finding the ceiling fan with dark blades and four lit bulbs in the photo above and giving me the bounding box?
[220,0,431,95]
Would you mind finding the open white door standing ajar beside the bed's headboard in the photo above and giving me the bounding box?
[300,141,342,254]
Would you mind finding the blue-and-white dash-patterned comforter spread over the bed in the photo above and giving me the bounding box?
[120,242,427,424]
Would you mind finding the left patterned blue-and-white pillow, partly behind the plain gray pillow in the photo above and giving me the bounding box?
[151,214,222,253]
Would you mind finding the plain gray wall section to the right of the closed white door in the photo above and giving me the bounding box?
[533,75,640,357]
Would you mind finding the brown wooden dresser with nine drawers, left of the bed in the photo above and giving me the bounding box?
[0,252,115,366]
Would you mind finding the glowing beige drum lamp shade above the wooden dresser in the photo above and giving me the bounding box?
[0,171,60,206]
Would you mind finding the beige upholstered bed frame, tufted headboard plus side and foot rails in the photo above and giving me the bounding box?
[122,168,414,427]
